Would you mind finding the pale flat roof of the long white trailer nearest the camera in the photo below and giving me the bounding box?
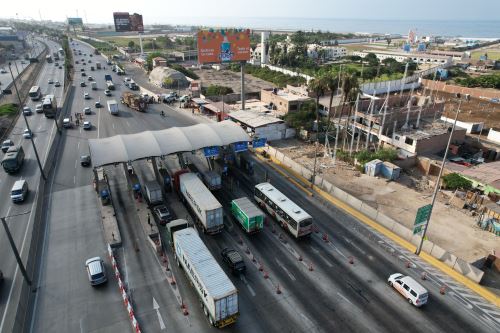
[174,228,237,299]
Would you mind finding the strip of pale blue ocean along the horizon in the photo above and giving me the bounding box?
[162,17,500,38]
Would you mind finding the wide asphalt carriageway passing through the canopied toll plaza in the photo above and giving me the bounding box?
[31,39,499,332]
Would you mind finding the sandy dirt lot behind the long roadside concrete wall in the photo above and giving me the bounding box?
[273,140,500,262]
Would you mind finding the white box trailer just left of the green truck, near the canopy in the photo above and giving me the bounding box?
[179,173,224,234]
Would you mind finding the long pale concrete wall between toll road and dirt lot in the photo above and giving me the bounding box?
[265,146,484,283]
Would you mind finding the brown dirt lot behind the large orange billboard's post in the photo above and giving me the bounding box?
[195,69,274,93]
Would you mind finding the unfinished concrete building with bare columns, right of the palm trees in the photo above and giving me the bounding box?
[349,94,466,155]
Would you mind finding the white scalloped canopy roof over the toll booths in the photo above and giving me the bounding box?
[89,120,250,167]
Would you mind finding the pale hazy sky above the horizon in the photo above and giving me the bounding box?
[0,0,500,22]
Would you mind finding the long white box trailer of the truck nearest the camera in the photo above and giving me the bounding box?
[173,226,239,328]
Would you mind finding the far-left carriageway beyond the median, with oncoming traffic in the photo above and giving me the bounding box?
[0,37,64,331]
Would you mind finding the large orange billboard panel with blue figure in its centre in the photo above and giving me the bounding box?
[197,29,250,64]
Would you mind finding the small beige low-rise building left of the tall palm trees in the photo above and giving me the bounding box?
[260,88,311,115]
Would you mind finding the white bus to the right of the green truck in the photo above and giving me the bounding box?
[254,183,312,238]
